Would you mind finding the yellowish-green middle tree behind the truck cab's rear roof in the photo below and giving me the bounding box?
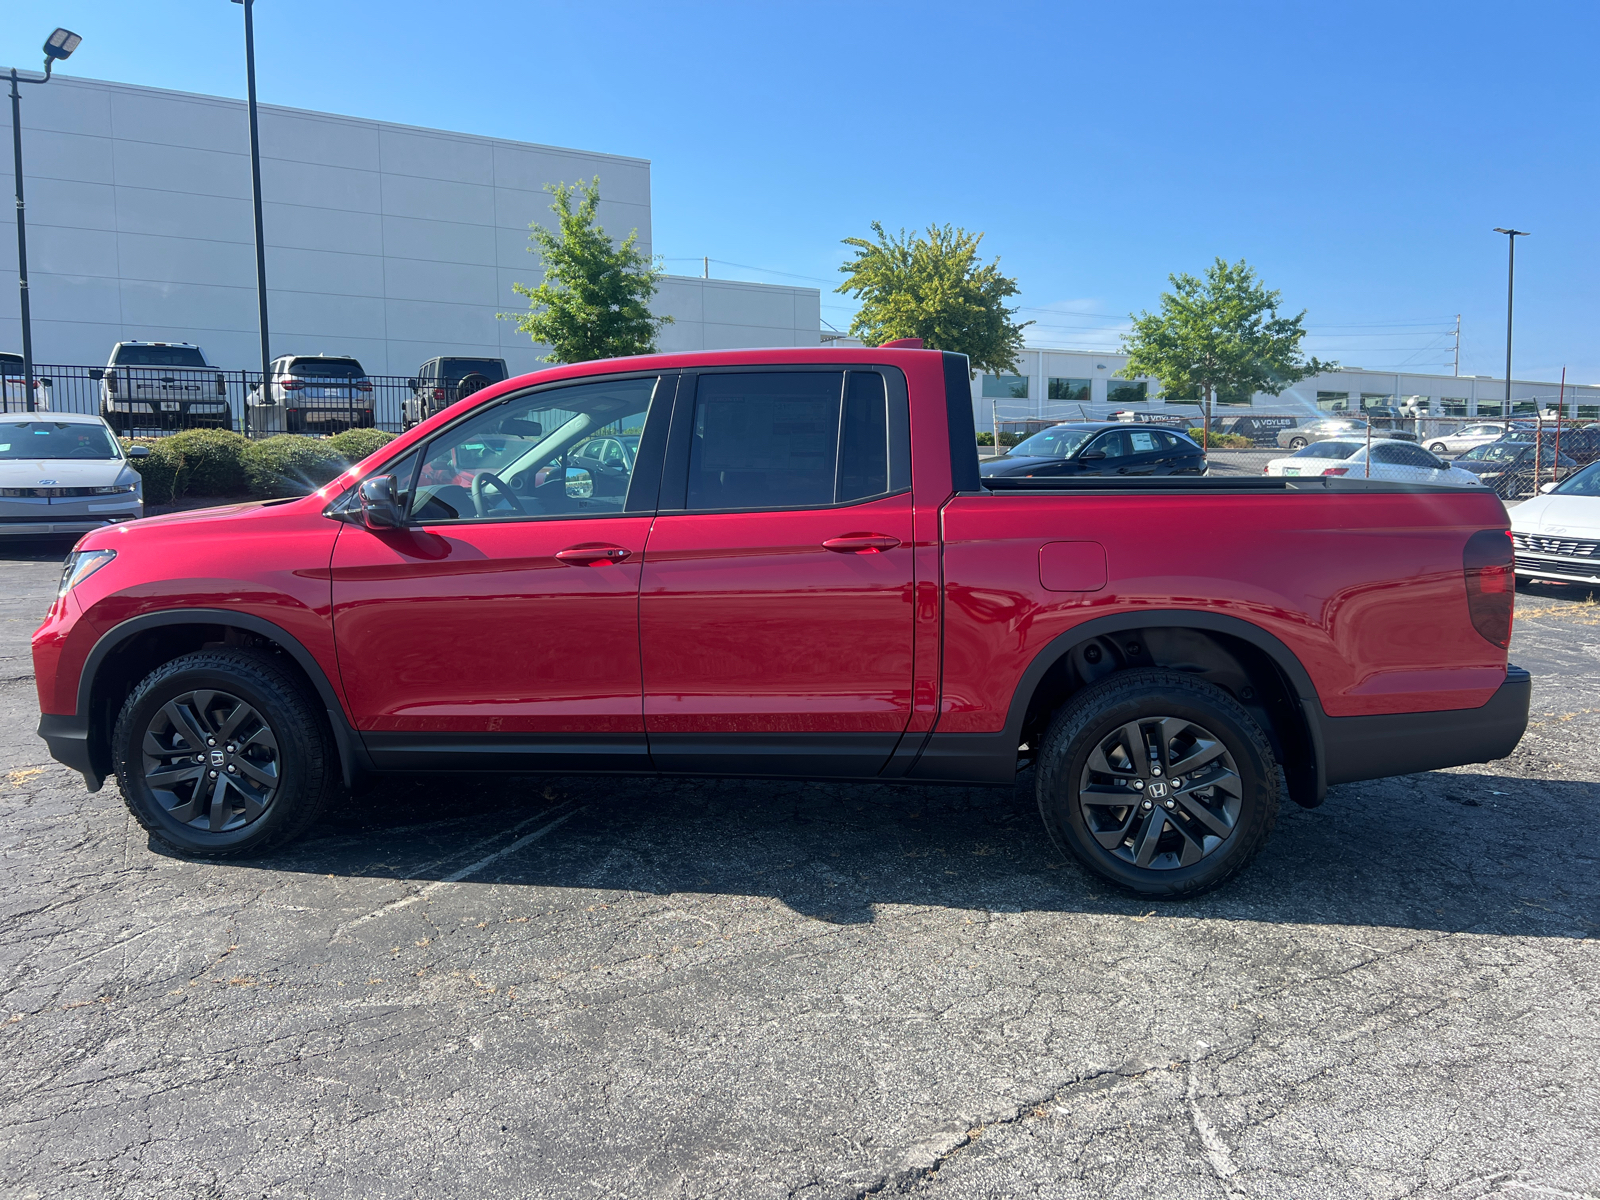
[837,221,1034,374]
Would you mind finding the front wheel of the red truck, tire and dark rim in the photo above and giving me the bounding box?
[112,650,339,858]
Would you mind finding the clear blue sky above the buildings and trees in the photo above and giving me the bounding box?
[9,0,1600,381]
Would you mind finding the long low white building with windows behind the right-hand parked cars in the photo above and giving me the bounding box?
[973,349,1600,432]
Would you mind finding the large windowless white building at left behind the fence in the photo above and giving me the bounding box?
[0,75,821,376]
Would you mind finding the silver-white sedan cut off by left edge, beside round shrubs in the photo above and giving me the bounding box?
[0,413,150,538]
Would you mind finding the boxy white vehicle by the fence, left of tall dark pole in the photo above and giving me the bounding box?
[101,342,234,437]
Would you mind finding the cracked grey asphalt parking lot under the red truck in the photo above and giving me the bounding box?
[0,546,1600,1200]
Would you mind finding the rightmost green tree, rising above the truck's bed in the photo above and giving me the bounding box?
[1117,258,1338,429]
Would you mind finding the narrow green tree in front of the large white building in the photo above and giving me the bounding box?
[499,176,672,363]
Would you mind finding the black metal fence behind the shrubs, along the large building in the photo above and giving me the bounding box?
[0,363,438,437]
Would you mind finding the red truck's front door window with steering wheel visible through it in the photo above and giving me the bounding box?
[411,378,659,523]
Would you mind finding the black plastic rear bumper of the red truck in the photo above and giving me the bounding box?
[1322,667,1533,784]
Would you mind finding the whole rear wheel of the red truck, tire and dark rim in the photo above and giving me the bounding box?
[1037,670,1278,899]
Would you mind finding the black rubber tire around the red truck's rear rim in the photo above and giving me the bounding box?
[1037,669,1282,899]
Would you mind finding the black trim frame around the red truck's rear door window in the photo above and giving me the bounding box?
[656,363,912,517]
